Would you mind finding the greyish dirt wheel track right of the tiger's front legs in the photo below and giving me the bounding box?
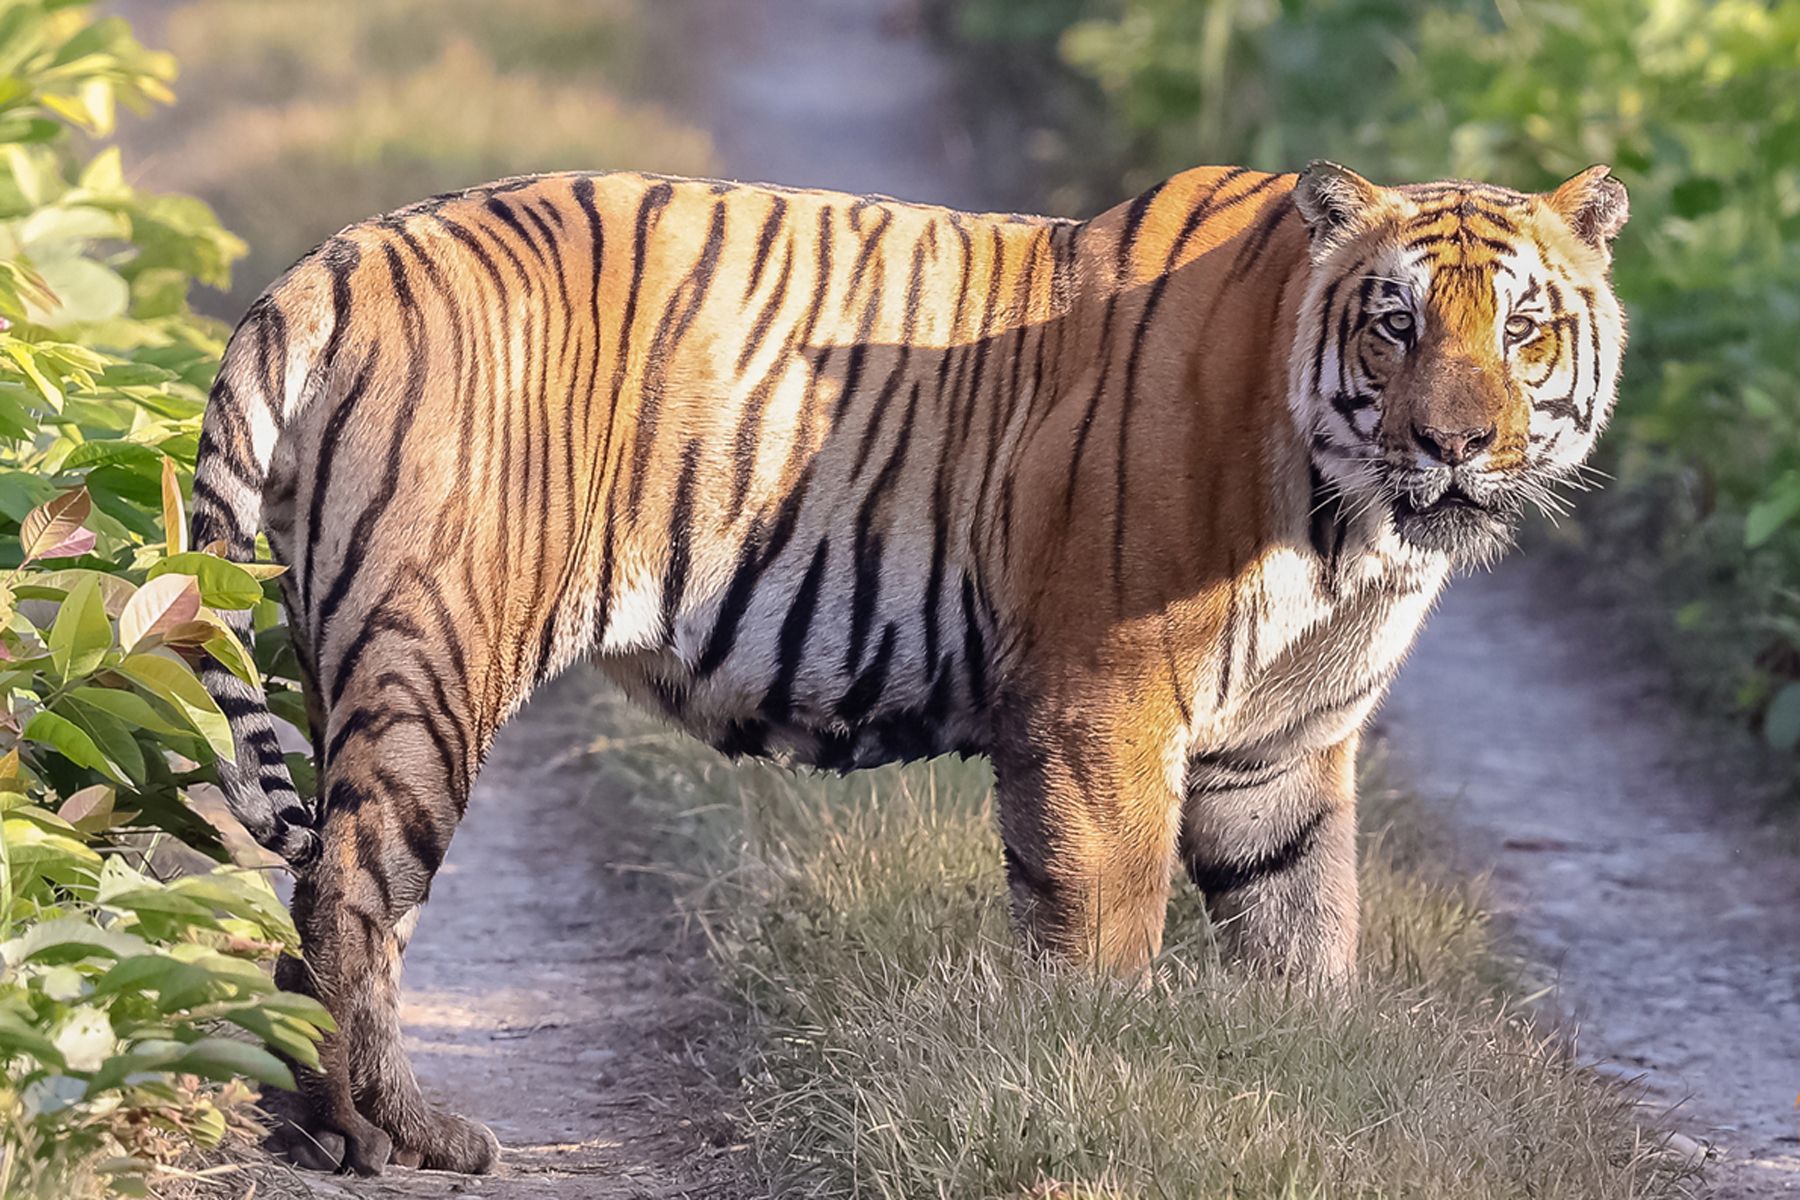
[1381,558,1800,1200]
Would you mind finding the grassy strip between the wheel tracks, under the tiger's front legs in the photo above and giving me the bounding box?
[583,694,1685,1200]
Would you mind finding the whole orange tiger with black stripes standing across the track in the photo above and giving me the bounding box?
[191,162,1629,1175]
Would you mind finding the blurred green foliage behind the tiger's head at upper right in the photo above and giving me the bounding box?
[941,0,1800,759]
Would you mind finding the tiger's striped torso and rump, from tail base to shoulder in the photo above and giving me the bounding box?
[221,175,1144,784]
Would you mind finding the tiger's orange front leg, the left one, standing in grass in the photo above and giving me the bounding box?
[992,683,1181,979]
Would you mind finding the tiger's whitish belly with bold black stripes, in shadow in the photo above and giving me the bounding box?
[598,513,994,770]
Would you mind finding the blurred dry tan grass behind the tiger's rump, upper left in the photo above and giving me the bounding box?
[128,0,711,317]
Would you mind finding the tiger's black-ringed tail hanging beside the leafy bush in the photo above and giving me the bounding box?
[189,295,329,869]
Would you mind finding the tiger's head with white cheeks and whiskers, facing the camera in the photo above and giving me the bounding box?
[1291,162,1627,563]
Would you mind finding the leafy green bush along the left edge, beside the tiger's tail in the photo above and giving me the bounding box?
[0,0,329,1198]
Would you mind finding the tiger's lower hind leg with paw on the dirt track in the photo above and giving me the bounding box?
[277,671,499,1175]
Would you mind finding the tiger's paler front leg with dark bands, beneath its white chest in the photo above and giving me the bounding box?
[1181,736,1357,982]
